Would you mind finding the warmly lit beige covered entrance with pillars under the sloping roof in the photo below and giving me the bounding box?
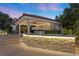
[16,13,52,35]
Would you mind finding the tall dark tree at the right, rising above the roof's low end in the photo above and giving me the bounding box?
[59,3,79,34]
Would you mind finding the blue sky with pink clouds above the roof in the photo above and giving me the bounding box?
[0,3,69,19]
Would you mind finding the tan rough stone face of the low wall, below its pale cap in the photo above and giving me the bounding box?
[23,37,75,53]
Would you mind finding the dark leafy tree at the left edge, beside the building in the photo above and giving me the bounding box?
[0,12,13,31]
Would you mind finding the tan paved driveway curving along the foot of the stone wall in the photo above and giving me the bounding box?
[0,35,75,56]
